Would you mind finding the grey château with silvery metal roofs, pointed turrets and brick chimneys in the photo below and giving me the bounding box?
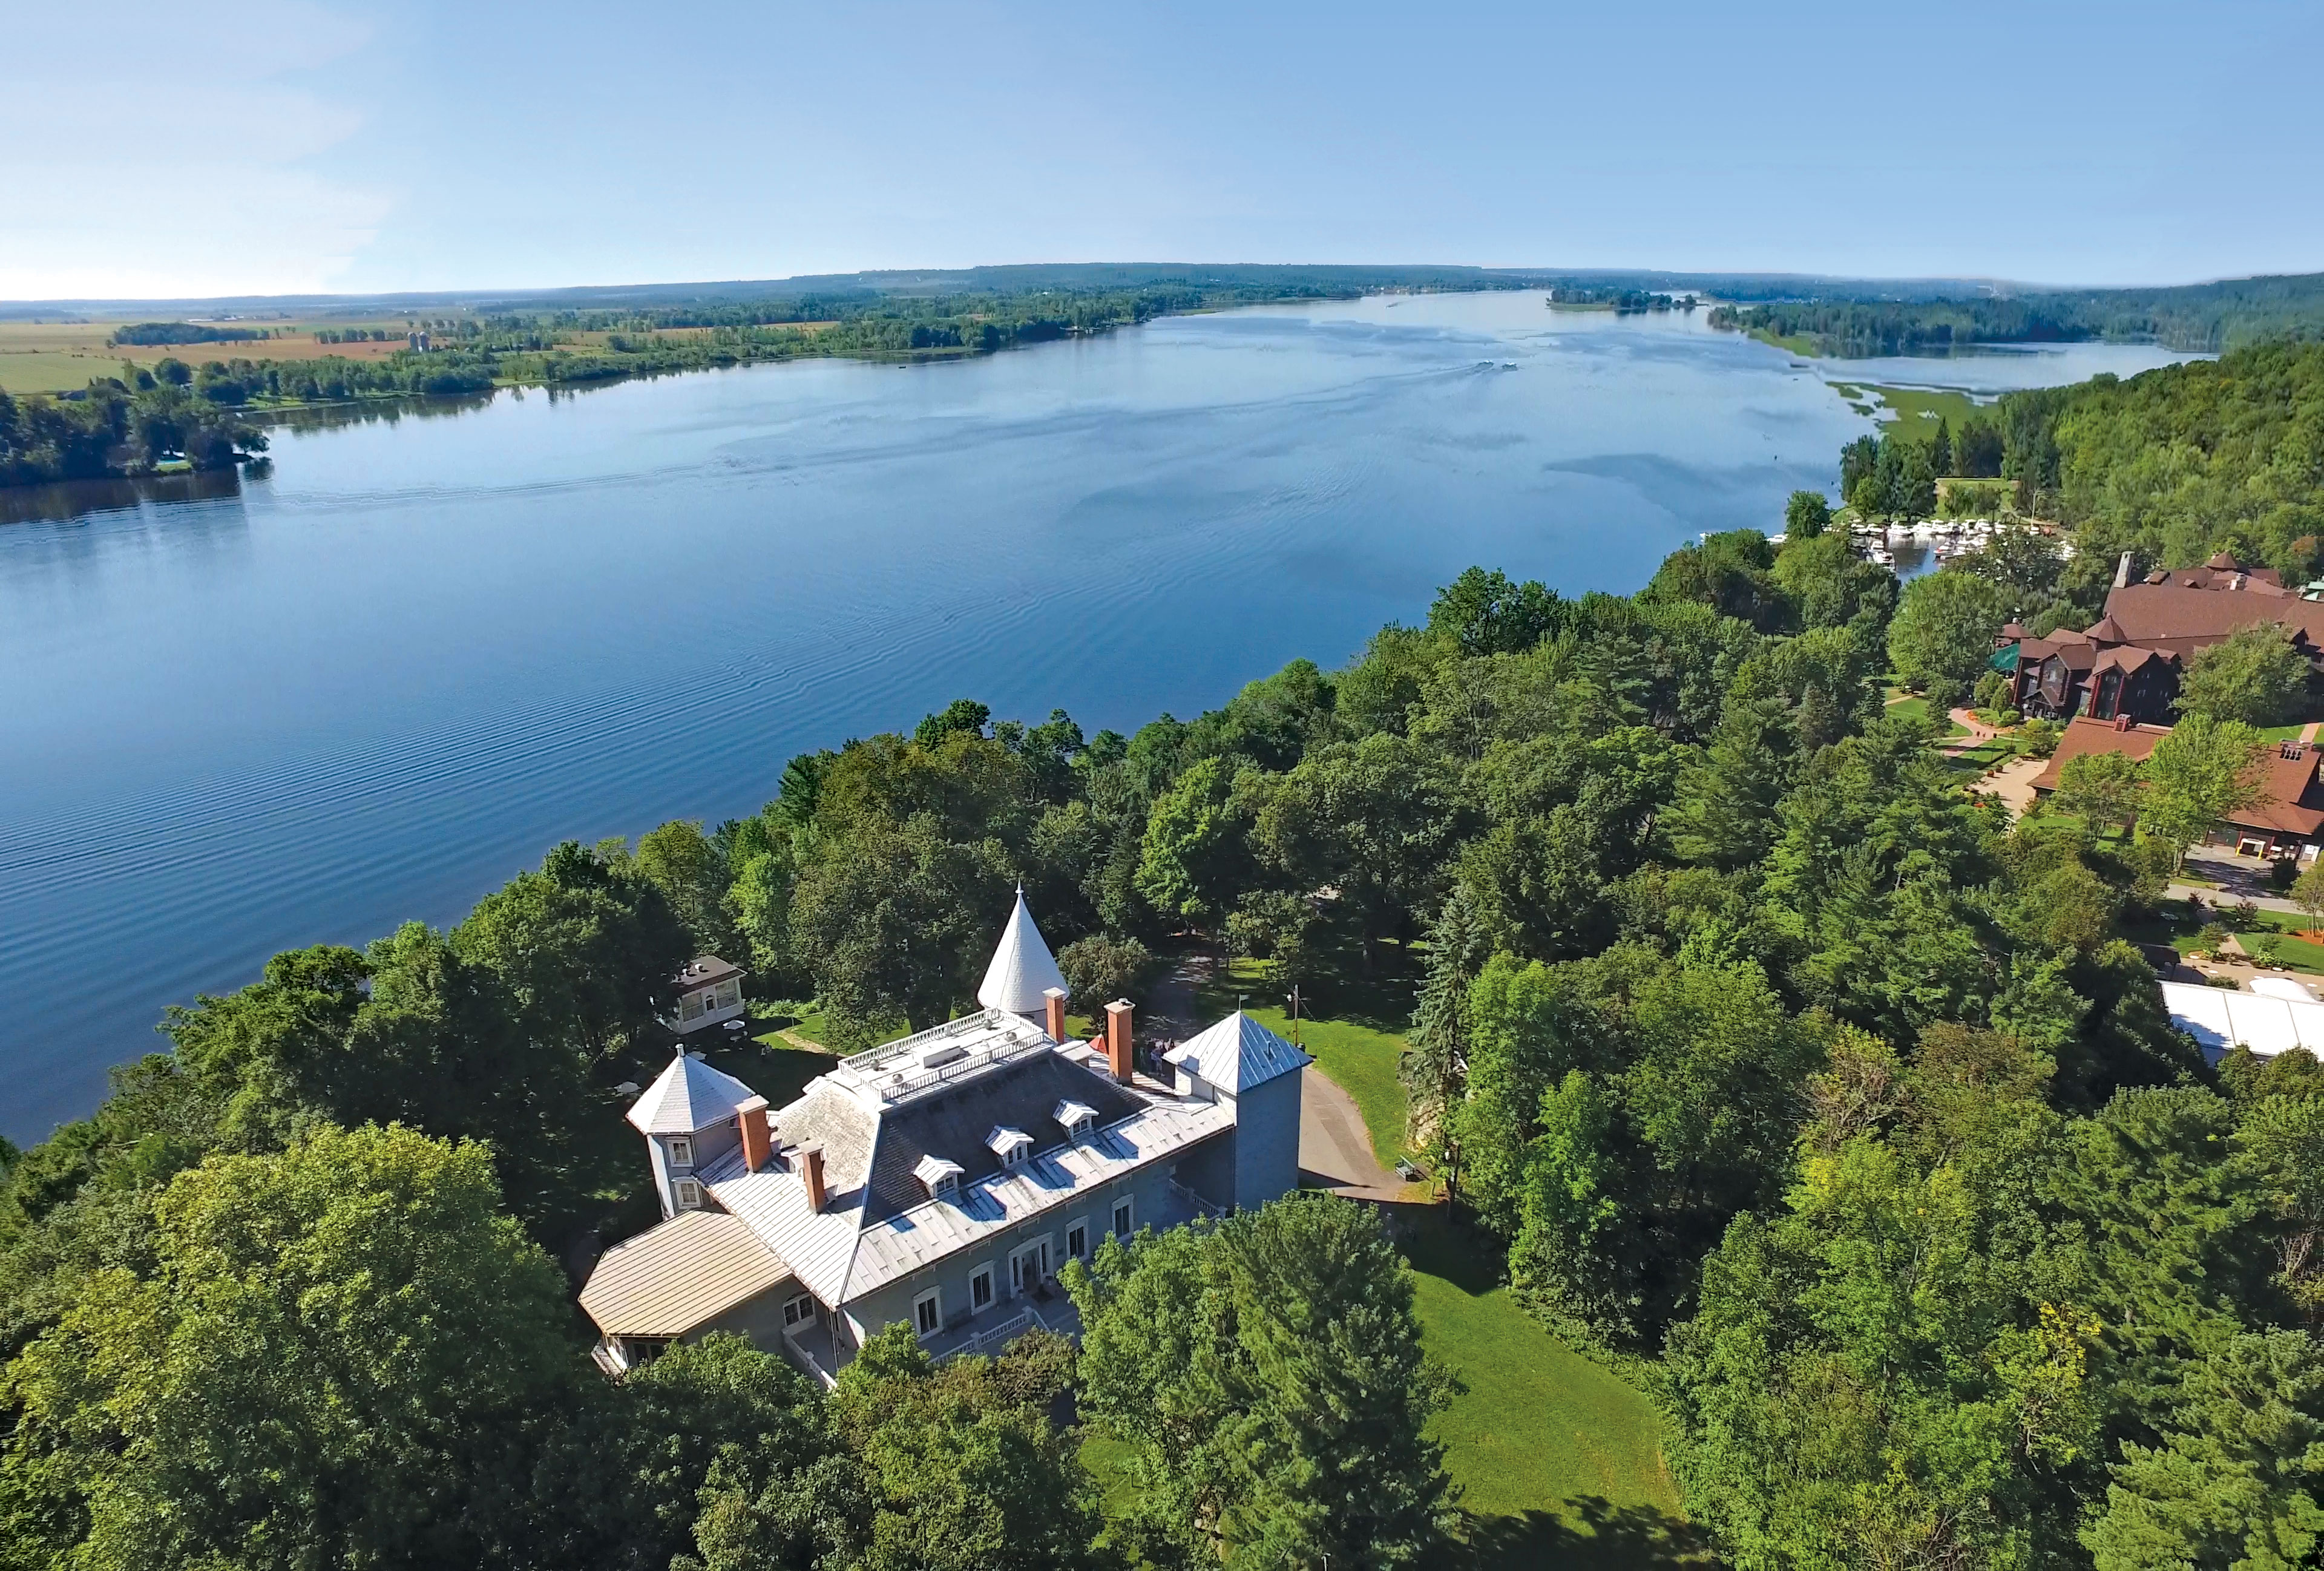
[581,893,1308,1383]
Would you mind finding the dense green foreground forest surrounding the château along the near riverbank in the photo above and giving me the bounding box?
[0,490,2324,1571]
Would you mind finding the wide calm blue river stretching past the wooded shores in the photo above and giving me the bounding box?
[0,293,2173,1141]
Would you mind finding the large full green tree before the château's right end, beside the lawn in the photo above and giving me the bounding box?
[1065,1195,1455,1566]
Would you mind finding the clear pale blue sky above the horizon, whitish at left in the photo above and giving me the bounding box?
[0,0,2324,300]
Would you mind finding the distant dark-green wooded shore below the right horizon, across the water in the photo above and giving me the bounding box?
[1708,274,2324,358]
